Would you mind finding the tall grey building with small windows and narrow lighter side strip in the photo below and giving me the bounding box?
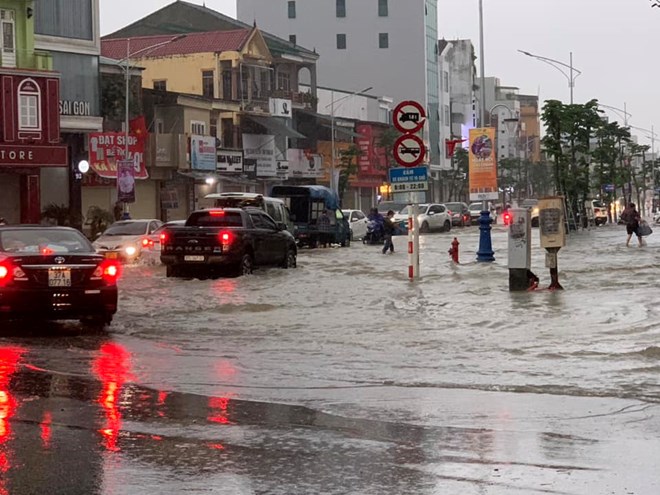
[237,0,444,172]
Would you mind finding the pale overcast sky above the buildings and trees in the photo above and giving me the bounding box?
[101,0,660,149]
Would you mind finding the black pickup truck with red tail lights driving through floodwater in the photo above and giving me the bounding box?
[160,208,297,279]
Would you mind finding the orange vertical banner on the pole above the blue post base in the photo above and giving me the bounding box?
[469,127,499,201]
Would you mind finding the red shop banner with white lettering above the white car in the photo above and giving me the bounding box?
[89,132,149,179]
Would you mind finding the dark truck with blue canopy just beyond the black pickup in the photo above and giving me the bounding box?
[270,186,351,248]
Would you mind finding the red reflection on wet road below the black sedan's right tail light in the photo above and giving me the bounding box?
[93,342,133,452]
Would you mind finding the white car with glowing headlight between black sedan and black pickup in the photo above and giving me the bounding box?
[93,218,163,262]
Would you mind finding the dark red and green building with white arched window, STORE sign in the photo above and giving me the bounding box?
[0,0,70,223]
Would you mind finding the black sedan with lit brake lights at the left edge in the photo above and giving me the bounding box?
[0,225,120,326]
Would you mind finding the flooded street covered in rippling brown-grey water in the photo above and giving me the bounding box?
[0,226,660,495]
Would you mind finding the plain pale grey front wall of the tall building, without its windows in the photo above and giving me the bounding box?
[237,0,428,108]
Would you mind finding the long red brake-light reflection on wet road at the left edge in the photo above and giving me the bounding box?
[0,347,26,495]
